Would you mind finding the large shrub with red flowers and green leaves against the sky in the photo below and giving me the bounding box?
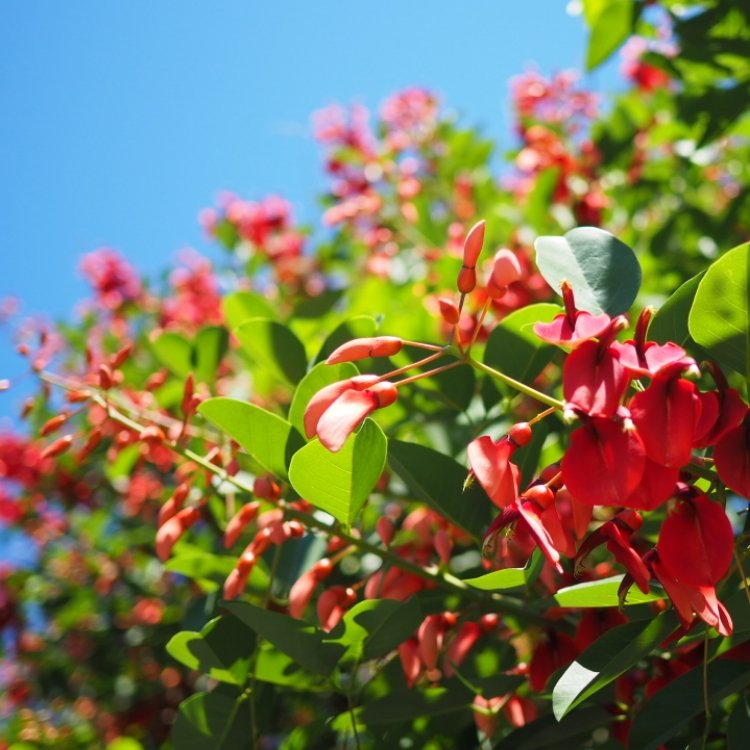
[0,3,750,750]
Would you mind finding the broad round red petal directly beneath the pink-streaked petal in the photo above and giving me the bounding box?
[562,418,646,505]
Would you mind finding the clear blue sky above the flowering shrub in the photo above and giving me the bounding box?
[0,0,615,426]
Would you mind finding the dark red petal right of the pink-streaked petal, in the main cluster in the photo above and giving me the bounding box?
[630,375,700,466]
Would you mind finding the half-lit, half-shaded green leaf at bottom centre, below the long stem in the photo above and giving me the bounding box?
[331,597,424,661]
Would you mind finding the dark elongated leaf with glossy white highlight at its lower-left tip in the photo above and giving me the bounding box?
[552,612,677,721]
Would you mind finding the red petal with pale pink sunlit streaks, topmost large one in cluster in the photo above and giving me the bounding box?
[563,341,628,417]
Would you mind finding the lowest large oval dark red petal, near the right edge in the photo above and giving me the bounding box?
[658,495,734,586]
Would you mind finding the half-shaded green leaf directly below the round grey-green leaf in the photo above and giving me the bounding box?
[484,302,561,383]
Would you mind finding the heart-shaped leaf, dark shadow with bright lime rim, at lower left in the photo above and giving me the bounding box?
[167,617,255,686]
